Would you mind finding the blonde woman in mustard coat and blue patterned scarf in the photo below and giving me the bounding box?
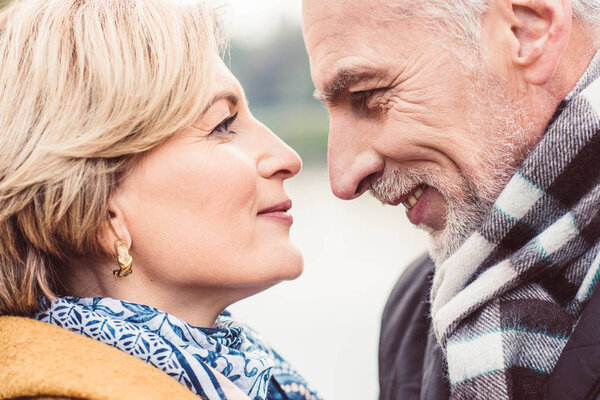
[0,0,317,399]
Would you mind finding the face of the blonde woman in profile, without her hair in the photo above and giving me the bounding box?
[111,63,302,302]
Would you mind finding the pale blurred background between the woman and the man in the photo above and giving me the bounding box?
[0,0,427,400]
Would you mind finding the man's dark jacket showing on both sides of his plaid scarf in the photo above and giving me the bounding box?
[379,256,600,400]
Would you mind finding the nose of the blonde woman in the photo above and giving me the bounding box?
[258,128,302,179]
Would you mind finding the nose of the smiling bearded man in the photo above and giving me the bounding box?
[328,124,385,200]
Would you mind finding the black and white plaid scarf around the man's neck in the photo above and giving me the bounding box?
[431,54,600,400]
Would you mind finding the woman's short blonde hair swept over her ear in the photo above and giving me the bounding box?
[0,0,221,315]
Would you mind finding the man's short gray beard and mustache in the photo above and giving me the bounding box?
[371,74,533,265]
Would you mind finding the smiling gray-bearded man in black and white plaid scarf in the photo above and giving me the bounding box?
[303,0,600,399]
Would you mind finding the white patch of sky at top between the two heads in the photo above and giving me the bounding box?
[226,0,302,45]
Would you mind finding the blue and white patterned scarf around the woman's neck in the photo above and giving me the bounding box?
[35,297,319,400]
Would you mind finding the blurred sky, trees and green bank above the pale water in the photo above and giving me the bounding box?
[224,0,328,168]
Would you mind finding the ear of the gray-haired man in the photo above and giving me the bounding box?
[508,0,572,86]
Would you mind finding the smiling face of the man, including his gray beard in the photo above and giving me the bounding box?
[303,0,532,262]
